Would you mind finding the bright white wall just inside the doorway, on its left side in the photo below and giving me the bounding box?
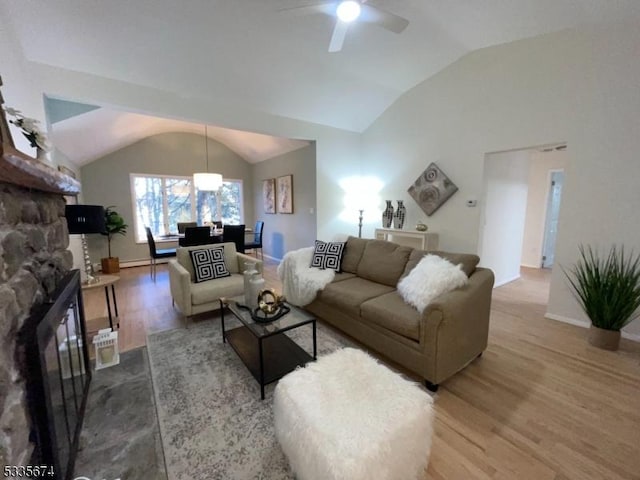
[479,151,530,286]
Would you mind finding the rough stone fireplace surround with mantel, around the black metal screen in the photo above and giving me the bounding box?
[0,97,80,468]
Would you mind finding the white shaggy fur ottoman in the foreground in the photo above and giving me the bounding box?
[273,348,433,480]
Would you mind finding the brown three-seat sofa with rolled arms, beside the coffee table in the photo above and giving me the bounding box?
[305,237,494,391]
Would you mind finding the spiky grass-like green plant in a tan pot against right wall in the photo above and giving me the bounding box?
[563,245,640,350]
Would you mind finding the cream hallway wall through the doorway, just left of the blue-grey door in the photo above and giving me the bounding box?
[521,150,568,268]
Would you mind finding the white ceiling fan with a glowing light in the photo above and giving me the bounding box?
[284,0,409,52]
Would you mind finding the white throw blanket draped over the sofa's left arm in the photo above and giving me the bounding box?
[278,247,335,307]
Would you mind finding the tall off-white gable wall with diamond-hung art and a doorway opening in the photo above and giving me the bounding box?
[363,24,640,334]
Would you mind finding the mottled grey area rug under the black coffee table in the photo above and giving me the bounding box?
[147,318,353,480]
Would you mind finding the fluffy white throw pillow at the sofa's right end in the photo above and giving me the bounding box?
[398,255,469,313]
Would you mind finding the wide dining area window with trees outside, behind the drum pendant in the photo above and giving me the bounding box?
[131,174,243,243]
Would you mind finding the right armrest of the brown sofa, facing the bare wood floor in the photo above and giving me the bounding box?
[421,268,494,383]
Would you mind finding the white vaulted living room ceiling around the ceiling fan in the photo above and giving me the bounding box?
[5,0,640,161]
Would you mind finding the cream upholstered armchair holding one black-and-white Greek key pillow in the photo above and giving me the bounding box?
[169,242,262,321]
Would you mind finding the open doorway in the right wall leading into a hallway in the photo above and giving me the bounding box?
[478,144,568,286]
